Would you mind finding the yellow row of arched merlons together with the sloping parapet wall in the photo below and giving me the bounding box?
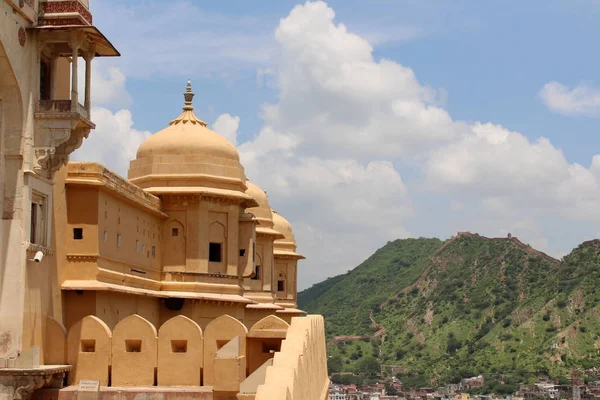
[45,314,329,400]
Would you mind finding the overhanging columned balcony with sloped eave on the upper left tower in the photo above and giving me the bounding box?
[33,17,119,179]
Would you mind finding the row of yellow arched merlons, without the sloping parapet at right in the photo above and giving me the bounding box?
[62,314,288,395]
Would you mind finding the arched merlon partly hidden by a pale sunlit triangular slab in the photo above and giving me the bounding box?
[203,314,248,386]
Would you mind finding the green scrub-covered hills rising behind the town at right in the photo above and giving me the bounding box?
[299,234,600,391]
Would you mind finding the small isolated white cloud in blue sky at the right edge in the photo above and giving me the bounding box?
[539,81,600,115]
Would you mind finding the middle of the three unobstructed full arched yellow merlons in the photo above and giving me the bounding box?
[111,314,157,386]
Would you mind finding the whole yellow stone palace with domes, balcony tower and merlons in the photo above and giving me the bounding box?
[0,0,328,400]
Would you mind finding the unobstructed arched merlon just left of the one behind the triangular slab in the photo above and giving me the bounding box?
[158,315,204,386]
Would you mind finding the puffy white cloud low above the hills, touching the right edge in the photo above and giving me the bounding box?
[425,123,600,221]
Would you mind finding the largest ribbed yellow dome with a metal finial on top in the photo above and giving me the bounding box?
[128,81,256,207]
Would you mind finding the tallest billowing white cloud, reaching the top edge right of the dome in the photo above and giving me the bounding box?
[263,2,462,161]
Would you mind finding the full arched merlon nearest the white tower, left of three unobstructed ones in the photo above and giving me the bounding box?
[67,315,112,386]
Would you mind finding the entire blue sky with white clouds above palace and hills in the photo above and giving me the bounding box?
[77,0,600,287]
